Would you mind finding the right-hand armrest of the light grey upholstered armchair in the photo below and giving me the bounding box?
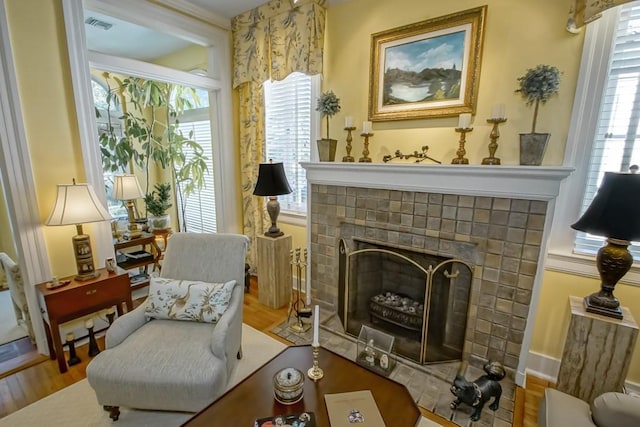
[211,281,244,363]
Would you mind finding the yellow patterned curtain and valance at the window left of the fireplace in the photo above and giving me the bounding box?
[231,0,326,267]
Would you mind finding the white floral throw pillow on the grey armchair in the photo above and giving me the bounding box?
[145,277,236,323]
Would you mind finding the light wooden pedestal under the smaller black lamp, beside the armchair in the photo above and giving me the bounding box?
[258,236,293,308]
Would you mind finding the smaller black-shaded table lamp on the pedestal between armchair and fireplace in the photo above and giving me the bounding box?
[253,160,293,237]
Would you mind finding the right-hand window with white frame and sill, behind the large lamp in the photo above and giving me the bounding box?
[545,2,640,284]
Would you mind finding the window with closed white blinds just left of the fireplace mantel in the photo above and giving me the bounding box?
[264,73,320,214]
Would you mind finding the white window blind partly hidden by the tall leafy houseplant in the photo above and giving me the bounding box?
[177,118,217,233]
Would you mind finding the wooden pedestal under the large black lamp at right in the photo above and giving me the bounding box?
[557,296,638,403]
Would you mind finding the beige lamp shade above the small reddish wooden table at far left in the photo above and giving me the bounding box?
[45,183,111,225]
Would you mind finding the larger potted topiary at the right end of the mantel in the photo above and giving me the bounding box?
[516,64,560,166]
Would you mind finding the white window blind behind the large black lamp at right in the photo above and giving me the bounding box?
[574,2,640,261]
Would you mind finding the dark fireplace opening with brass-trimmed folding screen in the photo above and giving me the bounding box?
[338,239,472,363]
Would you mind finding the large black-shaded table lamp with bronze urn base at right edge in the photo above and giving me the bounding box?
[571,172,640,319]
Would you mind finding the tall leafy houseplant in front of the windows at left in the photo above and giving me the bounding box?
[99,73,207,231]
